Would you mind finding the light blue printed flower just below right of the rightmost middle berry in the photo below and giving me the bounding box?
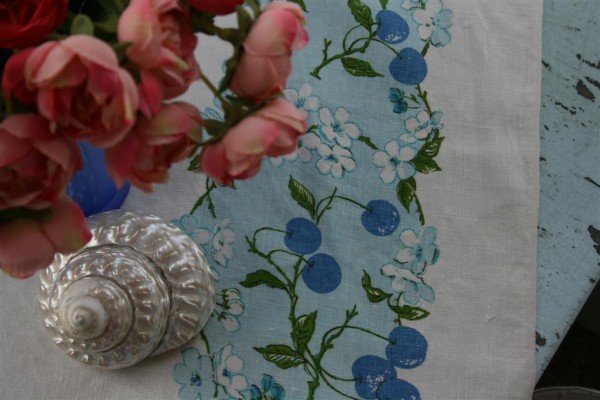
[395,226,440,276]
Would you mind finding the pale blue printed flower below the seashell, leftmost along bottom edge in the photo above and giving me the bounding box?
[173,347,215,400]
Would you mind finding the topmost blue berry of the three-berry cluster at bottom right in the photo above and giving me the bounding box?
[385,326,427,369]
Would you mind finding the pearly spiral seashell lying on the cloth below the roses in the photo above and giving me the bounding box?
[38,210,215,369]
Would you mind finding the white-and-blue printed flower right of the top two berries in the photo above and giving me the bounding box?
[413,0,453,47]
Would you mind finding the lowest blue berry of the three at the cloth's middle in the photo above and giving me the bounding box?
[302,253,342,293]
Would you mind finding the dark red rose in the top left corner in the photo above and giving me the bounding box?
[0,0,68,49]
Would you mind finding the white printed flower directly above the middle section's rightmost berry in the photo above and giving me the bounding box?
[373,140,417,184]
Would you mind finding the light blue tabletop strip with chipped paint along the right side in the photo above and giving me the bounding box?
[536,0,600,379]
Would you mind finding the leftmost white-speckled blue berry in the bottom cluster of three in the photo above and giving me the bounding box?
[352,355,396,399]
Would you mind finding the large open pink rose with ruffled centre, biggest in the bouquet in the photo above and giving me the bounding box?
[25,35,138,147]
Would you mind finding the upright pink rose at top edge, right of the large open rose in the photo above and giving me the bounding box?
[118,0,200,101]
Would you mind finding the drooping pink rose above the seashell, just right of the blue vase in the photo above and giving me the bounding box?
[106,102,202,192]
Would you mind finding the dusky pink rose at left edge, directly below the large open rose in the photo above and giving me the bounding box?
[0,114,81,210]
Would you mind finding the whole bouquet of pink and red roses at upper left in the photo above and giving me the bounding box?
[0,0,308,278]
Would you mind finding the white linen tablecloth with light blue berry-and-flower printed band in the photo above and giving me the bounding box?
[0,0,542,400]
